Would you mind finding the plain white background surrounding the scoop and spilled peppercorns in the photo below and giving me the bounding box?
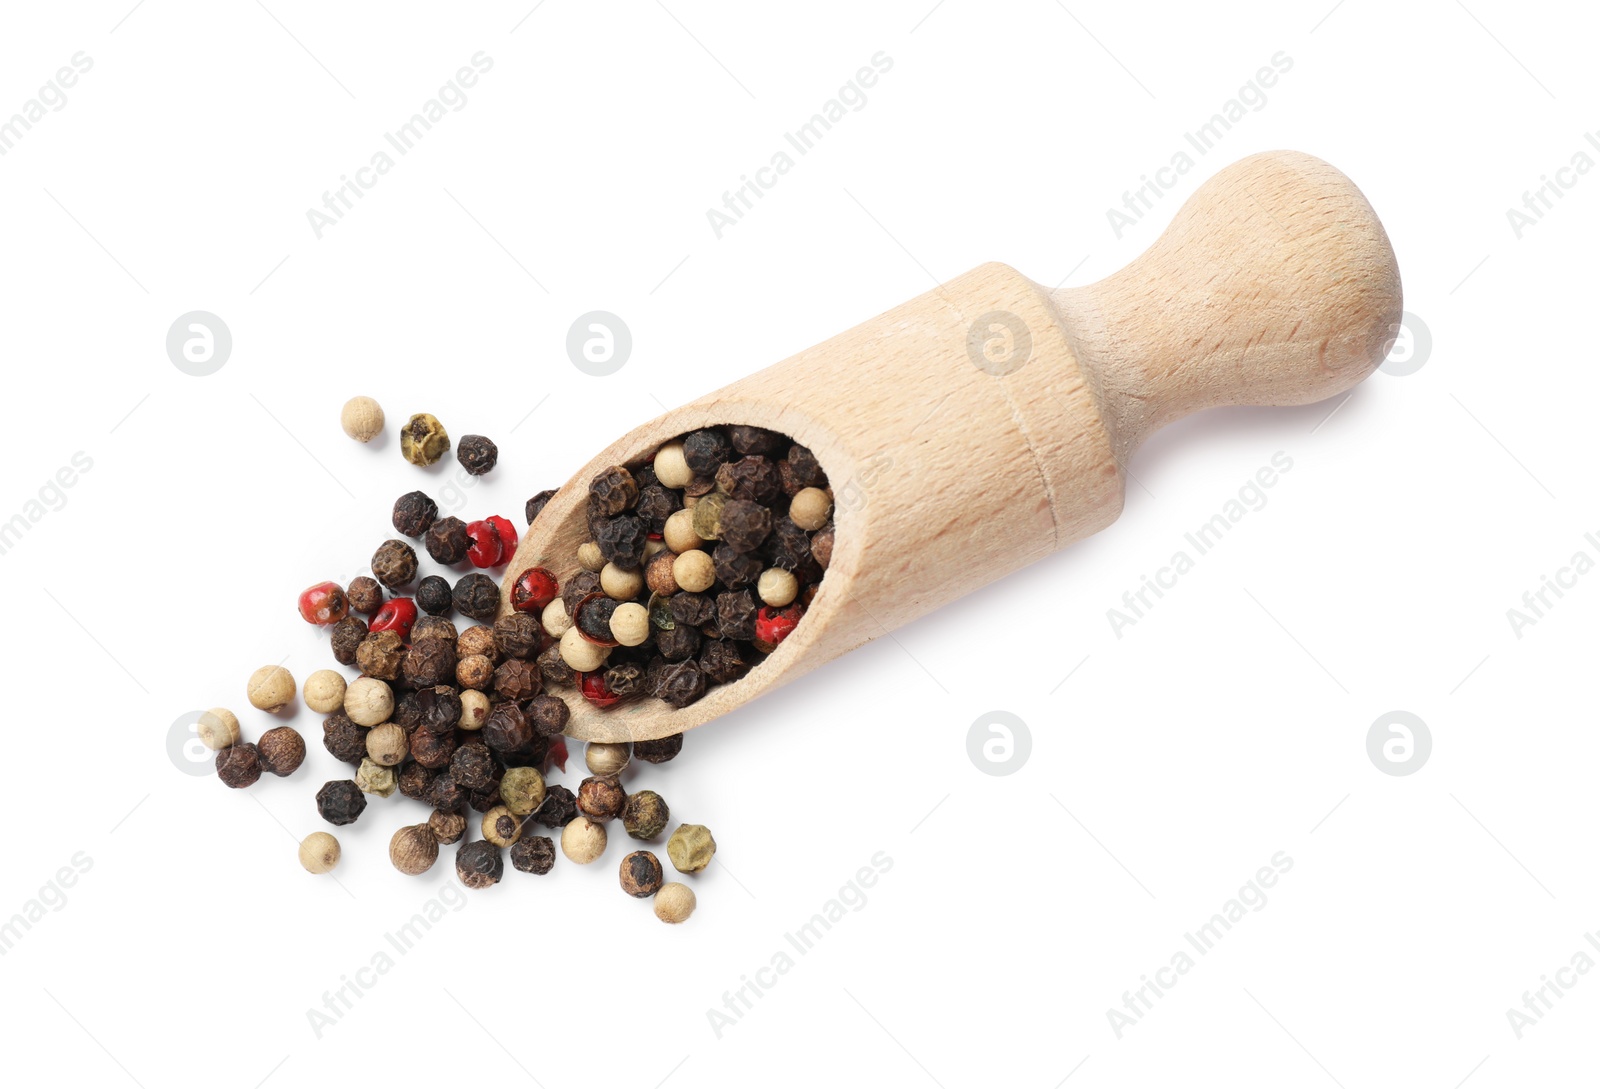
[0,0,1600,1089]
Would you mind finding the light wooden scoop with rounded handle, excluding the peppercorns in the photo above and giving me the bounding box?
[501,152,1400,740]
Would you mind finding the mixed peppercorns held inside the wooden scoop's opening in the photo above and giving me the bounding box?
[512,425,834,708]
